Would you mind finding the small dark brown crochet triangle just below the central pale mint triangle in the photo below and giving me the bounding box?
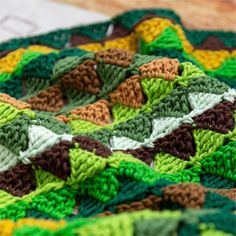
[123,147,154,165]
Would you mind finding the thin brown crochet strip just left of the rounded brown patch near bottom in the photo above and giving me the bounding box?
[117,195,161,213]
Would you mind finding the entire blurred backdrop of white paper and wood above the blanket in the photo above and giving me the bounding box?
[0,0,236,42]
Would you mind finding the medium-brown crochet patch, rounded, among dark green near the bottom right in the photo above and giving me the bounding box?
[163,183,205,208]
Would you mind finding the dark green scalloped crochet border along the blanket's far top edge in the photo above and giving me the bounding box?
[0,9,236,51]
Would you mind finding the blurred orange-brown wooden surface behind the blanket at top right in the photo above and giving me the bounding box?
[55,0,236,31]
